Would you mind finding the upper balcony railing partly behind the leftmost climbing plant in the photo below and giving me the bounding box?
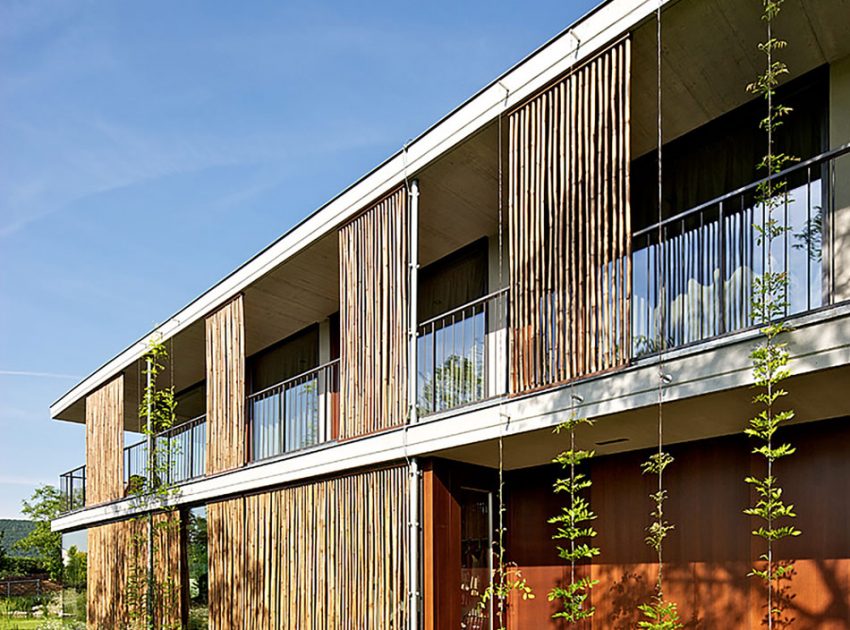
[124,416,207,491]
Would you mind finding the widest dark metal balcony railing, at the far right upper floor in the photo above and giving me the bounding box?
[632,145,850,357]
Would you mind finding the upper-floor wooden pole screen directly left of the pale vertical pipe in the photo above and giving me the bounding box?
[339,188,410,439]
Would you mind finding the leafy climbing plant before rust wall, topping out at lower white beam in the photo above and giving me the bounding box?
[549,397,599,623]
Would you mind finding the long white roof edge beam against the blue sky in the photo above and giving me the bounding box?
[50,0,675,418]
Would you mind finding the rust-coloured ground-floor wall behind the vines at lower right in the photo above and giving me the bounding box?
[507,418,850,629]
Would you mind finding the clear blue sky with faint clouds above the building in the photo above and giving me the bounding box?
[0,0,596,517]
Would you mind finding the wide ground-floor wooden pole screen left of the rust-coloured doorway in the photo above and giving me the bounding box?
[207,467,408,630]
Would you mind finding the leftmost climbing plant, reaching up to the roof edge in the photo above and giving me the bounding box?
[125,340,180,630]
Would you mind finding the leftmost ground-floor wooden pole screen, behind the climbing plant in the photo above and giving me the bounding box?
[87,512,183,630]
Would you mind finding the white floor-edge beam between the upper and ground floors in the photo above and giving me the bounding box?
[52,304,850,531]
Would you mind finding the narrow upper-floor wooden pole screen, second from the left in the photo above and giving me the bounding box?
[206,295,246,475]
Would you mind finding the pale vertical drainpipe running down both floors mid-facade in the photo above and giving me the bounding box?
[407,179,420,630]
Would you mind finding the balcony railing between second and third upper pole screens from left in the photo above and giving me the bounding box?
[247,359,339,461]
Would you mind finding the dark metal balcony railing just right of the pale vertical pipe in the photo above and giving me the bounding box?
[417,289,509,415]
